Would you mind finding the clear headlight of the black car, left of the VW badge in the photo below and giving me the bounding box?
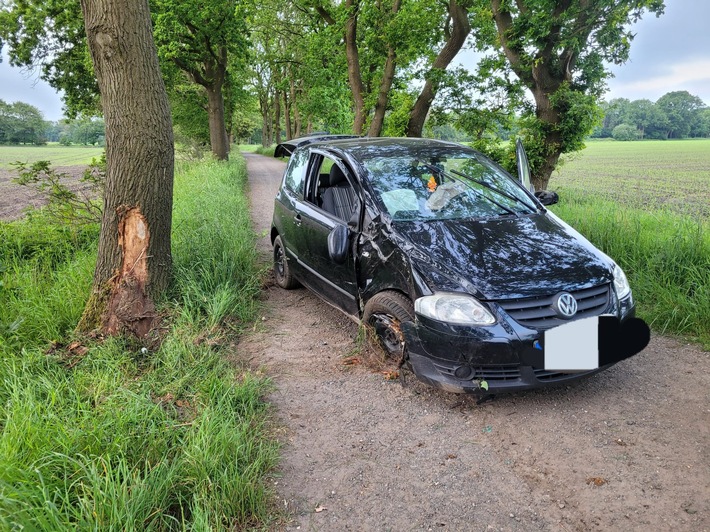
[414,293,496,325]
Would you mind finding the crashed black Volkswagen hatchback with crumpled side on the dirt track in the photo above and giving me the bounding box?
[271,137,647,392]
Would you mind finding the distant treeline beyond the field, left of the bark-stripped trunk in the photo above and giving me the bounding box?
[0,100,105,146]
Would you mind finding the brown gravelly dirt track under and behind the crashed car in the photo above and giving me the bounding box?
[239,154,710,531]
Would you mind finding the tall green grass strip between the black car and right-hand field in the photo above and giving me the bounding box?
[553,191,710,348]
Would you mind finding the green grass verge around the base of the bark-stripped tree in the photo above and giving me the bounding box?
[0,154,278,530]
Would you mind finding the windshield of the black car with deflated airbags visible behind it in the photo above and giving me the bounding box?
[364,151,537,221]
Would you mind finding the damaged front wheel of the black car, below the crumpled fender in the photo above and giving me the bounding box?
[362,291,414,360]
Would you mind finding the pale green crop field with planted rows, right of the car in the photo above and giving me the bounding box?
[549,139,710,220]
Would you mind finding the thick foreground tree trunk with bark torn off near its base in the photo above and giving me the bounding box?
[79,0,174,337]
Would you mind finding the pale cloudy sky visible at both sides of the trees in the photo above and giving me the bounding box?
[0,0,710,120]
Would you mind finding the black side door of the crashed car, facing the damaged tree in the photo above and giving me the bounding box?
[298,149,362,316]
